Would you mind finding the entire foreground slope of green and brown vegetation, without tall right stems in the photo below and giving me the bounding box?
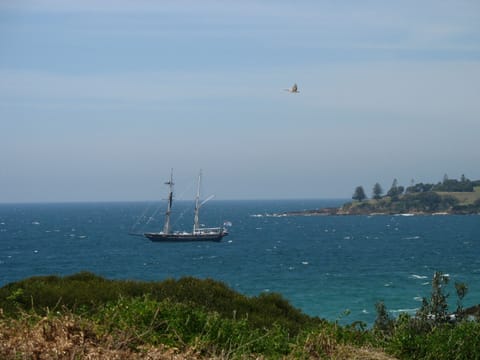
[0,273,480,359]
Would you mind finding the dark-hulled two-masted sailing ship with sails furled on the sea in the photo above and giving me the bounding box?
[143,170,228,242]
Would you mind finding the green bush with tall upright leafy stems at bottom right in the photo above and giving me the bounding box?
[374,272,480,360]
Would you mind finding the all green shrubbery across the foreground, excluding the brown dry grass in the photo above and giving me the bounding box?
[0,272,480,360]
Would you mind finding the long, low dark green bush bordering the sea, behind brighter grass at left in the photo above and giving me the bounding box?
[0,272,322,336]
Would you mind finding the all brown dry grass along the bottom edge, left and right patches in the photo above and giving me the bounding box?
[0,313,395,360]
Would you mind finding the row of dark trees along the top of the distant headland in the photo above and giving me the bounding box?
[352,174,480,201]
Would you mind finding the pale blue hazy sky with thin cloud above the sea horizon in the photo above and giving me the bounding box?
[0,0,480,203]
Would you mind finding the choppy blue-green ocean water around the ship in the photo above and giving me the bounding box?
[0,200,480,324]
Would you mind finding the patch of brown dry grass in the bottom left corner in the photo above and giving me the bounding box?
[0,314,201,360]
